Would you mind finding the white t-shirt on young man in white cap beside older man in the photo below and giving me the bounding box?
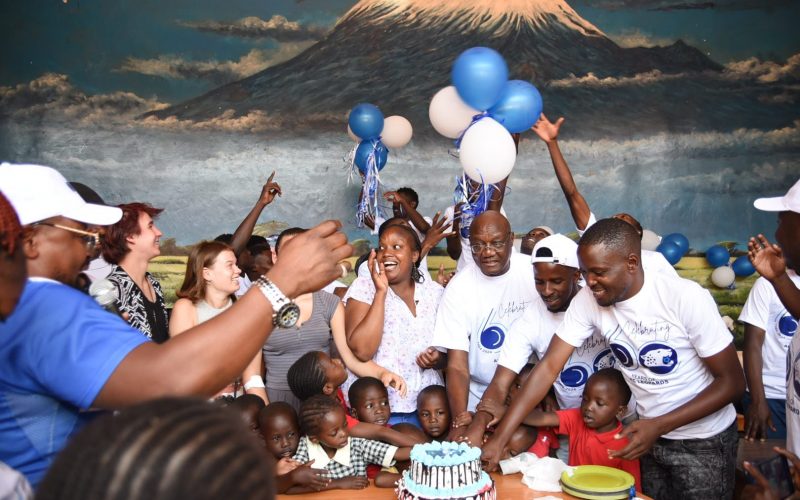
[497,299,612,410]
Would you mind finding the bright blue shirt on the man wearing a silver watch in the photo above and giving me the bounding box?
[0,279,148,487]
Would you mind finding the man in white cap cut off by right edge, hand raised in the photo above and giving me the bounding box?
[748,180,800,454]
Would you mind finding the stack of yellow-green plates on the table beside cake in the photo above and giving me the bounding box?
[561,465,635,500]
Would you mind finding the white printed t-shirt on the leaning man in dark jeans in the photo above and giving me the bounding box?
[556,273,736,439]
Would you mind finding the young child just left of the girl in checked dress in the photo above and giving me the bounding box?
[258,401,330,493]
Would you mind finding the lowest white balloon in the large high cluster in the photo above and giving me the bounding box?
[458,118,517,184]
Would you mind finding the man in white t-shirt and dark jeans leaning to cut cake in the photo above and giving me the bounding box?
[483,218,744,500]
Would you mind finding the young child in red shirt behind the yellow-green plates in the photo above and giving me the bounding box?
[504,368,641,491]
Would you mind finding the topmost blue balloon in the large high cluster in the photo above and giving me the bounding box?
[454,47,508,111]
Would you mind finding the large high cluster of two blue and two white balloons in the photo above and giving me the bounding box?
[428,47,542,184]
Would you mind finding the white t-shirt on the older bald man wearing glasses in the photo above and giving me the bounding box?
[432,254,541,411]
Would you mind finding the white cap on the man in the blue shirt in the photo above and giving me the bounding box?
[0,163,122,226]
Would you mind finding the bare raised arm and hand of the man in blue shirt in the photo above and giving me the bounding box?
[93,221,353,408]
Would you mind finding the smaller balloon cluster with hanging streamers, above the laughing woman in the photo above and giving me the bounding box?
[347,103,413,227]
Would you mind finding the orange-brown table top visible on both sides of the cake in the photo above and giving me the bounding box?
[278,473,650,500]
